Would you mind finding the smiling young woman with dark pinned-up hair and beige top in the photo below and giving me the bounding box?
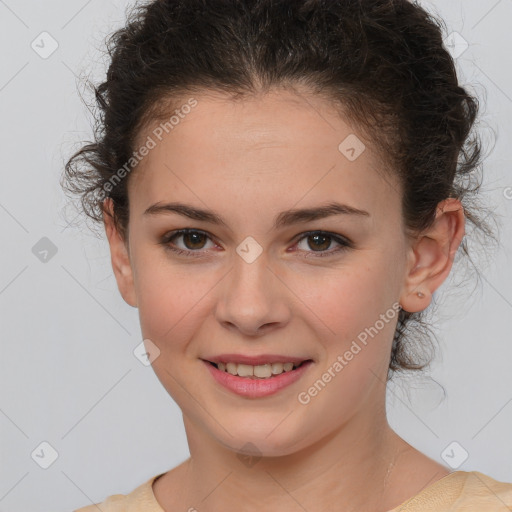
[65,0,512,512]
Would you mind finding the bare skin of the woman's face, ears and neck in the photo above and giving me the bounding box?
[104,89,464,512]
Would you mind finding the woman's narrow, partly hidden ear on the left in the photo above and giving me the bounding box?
[103,198,137,307]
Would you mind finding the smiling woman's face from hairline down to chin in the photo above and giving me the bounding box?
[105,90,444,455]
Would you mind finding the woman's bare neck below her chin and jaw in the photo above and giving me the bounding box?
[163,411,416,512]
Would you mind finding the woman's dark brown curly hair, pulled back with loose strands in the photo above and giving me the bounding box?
[61,0,495,378]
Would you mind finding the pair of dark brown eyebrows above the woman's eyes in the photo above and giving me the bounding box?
[143,202,371,229]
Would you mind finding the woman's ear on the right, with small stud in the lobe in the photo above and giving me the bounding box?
[400,198,466,313]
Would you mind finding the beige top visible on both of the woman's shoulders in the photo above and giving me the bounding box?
[74,471,512,512]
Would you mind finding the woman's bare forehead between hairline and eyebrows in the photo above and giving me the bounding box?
[129,90,399,226]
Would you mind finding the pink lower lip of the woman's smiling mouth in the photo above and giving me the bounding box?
[203,361,313,398]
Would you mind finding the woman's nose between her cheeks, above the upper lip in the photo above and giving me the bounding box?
[216,252,291,336]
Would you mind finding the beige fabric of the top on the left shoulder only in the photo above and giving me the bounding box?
[73,474,163,512]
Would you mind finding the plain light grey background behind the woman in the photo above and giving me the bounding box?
[0,0,512,512]
